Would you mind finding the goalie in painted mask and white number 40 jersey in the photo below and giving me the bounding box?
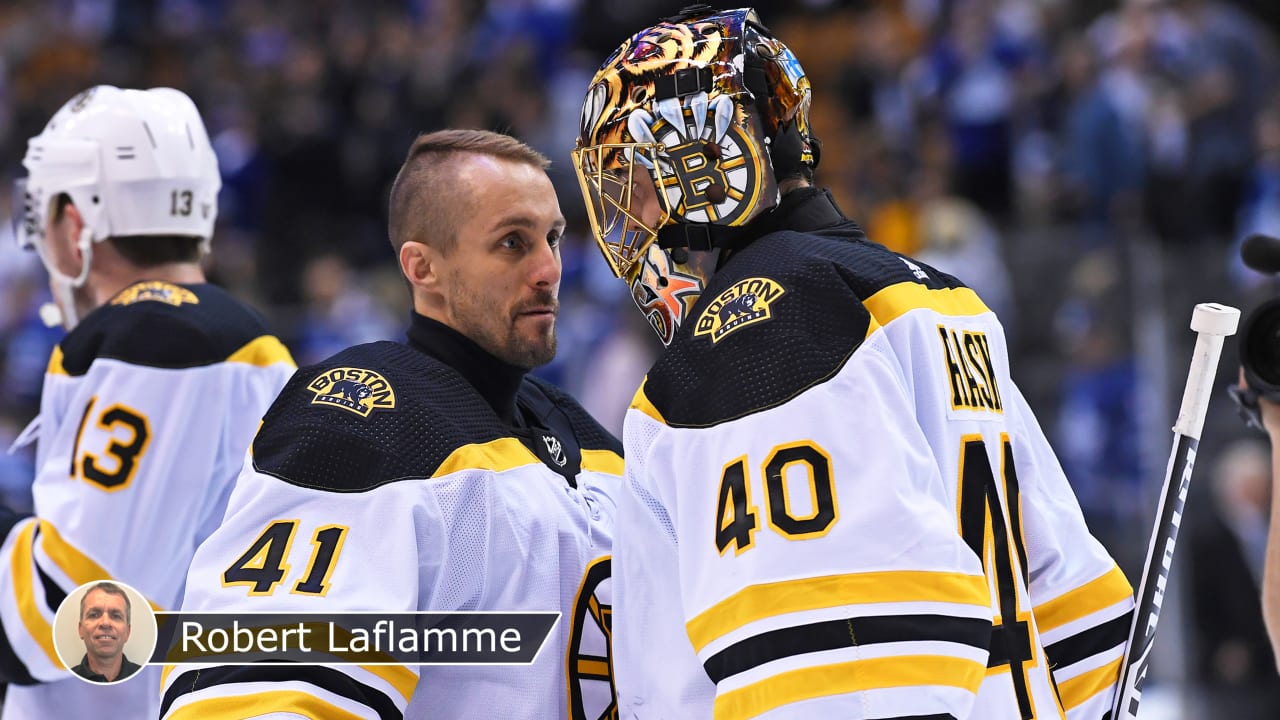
[573,6,1133,720]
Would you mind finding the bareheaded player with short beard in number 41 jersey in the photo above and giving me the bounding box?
[163,131,622,720]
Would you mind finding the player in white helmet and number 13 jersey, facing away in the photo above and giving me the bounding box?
[0,86,294,720]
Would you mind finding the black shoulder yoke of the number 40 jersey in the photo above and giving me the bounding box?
[644,225,963,427]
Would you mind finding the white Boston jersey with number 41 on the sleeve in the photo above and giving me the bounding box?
[163,335,622,720]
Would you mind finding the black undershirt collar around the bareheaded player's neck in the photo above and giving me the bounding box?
[406,313,527,424]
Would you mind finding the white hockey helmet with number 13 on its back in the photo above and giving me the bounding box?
[14,85,221,329]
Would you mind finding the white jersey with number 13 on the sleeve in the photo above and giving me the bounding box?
[0,282,294,720]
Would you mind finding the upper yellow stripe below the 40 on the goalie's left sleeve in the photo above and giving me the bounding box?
[685,570,991,652]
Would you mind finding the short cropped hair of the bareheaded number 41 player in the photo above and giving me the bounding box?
[388,129,550,252]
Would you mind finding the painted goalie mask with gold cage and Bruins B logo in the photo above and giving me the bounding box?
[573,6,818,345]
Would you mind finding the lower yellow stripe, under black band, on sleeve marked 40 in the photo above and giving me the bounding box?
[713,655,987,720]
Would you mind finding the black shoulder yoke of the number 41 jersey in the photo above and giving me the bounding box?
[253,341,608,492]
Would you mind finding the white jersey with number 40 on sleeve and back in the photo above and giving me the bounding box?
[613,191,1133,720]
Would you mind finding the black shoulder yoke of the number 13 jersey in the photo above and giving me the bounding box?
[59,282,270,375]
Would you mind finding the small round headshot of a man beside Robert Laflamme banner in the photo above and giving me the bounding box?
[54,580,156,684]
